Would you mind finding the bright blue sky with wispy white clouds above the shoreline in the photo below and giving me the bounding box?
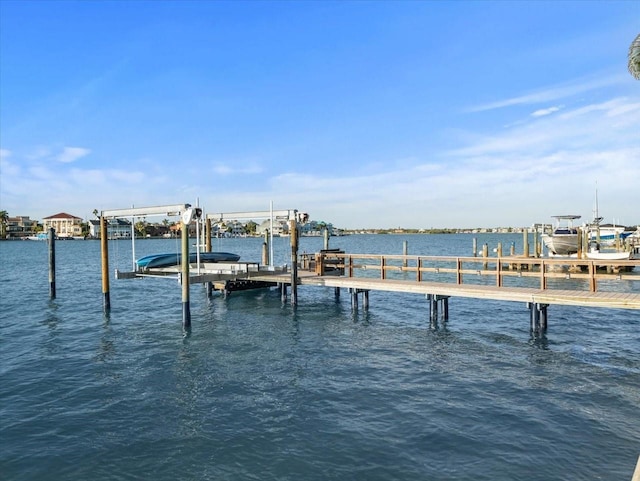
[0,0,640,228]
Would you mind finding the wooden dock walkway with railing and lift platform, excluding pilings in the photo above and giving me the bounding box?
[131,252,640,309]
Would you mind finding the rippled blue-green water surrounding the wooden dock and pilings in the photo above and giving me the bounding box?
[0,235,640,481]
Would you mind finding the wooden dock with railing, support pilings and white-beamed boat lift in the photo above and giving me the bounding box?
[100,204,640,331]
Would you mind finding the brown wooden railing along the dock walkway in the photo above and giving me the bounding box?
[301,250,640,292]
